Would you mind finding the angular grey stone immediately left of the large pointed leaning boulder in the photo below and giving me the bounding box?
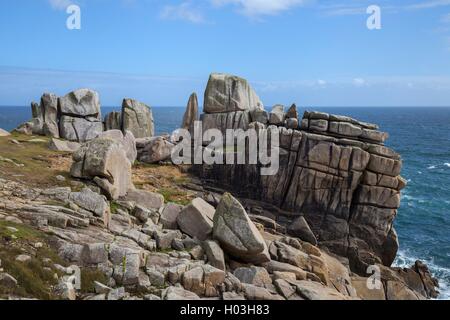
[177,198,214,241]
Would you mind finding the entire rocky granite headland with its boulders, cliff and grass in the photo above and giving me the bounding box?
[0,74,438,300]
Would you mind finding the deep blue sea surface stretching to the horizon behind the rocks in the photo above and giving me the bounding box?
[0,107,450,299]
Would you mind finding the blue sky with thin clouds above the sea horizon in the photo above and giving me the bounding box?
[0,0,450,107]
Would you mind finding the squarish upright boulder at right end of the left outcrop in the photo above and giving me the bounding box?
[122,99,155,139]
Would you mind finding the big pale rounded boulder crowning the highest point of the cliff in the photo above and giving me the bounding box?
[203,73,264,113]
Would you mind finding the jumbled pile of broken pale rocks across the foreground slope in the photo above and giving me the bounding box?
[0,180,436,300]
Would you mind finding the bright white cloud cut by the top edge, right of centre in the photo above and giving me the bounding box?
[211,0,311,17]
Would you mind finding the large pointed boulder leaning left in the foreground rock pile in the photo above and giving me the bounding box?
[213,193,270,264]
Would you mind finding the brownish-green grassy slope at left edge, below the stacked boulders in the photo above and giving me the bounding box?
[0,134,72,187]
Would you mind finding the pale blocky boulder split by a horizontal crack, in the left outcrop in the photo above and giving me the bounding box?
[59,89,103,142]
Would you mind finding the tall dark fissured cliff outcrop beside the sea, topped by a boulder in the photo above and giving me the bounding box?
[196,75,406,272]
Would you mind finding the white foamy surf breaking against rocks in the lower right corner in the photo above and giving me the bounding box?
[392,250,450,300]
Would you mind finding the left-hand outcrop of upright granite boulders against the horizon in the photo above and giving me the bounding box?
[16,89,154,143]
